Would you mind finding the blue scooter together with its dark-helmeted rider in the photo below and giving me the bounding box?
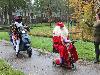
[10,16,32,57]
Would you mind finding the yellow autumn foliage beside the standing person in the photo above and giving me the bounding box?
[70,0,95,40]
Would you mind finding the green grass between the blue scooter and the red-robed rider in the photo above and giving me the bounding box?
[31,36,52,52]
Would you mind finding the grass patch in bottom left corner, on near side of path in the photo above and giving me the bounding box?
[0,59,24,75]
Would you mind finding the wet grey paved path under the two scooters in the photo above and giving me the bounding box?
[0,43,100,75]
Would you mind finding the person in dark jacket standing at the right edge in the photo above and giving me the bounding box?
[94,13,100,63]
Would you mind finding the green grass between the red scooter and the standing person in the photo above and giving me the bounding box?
[75,41,95,60]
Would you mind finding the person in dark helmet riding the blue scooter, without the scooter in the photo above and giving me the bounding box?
[12,16,24,55]
